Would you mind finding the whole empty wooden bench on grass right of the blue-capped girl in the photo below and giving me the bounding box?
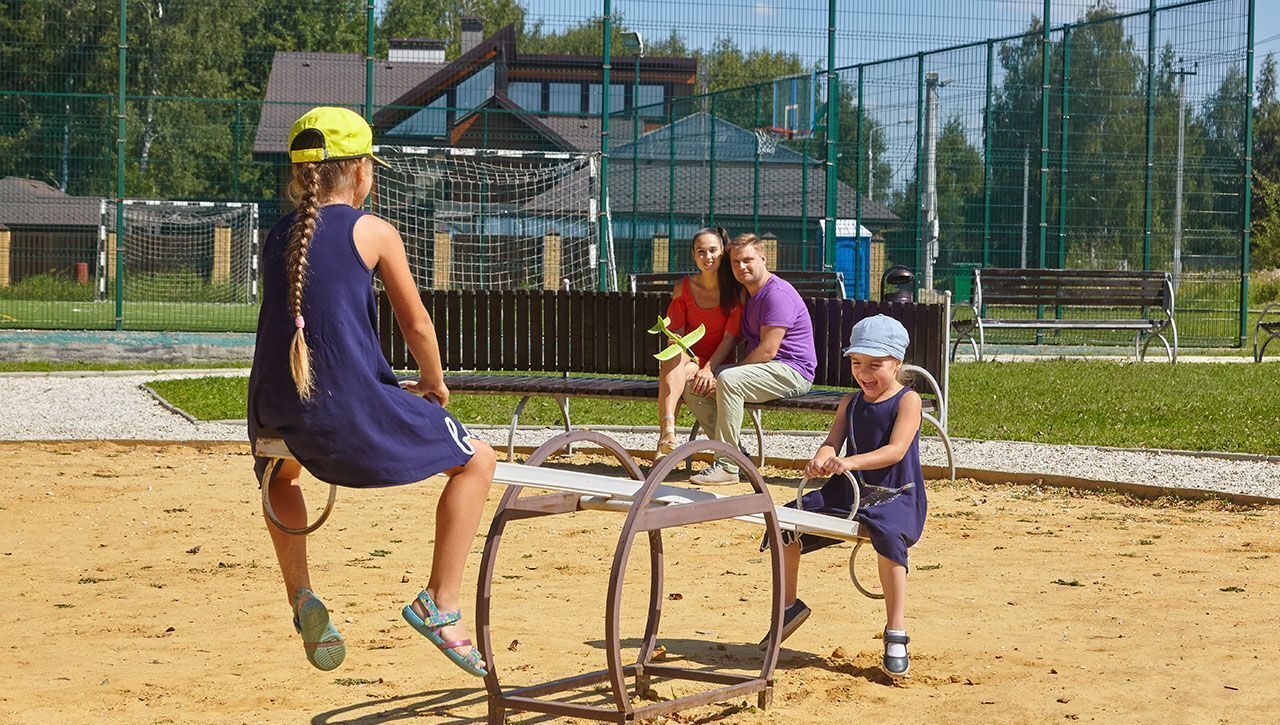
[951,269,1178,363]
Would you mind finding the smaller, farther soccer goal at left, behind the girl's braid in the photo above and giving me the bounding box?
[97,199,259,304]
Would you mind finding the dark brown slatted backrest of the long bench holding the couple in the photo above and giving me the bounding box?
[378,289,950,404]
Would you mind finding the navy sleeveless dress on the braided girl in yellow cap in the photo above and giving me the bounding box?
[248,204,475,488]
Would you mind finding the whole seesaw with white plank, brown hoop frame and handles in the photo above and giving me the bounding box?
[255,430,879,724]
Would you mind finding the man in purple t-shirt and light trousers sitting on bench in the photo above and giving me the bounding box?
[684,234,818,485]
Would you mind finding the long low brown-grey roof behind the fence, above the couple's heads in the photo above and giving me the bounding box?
[527,161,899,225]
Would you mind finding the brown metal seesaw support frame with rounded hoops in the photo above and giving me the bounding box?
[476,430,782,725]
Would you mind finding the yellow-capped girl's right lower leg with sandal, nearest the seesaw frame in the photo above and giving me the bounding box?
[413,438,497,655]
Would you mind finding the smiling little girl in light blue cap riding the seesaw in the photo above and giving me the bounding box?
[762,315,927,678]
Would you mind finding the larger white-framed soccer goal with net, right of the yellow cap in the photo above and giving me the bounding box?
[372,146,616,289]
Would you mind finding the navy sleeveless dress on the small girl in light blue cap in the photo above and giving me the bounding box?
[762,387,928,566]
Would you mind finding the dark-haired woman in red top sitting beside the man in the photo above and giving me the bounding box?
[658,227,742,456]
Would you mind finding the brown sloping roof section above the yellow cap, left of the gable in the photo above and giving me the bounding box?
[253,51,448,154]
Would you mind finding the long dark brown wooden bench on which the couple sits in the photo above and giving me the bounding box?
[378,289,955,478]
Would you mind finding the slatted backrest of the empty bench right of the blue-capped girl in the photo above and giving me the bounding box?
[973,269,1174,310]
